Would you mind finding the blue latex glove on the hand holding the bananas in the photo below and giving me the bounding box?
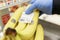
[26,0,53,14]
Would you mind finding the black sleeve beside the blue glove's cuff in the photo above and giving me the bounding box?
[52,0,60,14]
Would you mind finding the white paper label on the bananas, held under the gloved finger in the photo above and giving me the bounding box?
[19,12,34,23]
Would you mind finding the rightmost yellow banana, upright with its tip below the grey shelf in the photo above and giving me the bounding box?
[35,24,44,40]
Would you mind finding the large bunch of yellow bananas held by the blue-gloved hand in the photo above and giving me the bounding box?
[3,6,44,40]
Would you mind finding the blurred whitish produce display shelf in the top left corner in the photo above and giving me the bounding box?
[0,0,29,10]
